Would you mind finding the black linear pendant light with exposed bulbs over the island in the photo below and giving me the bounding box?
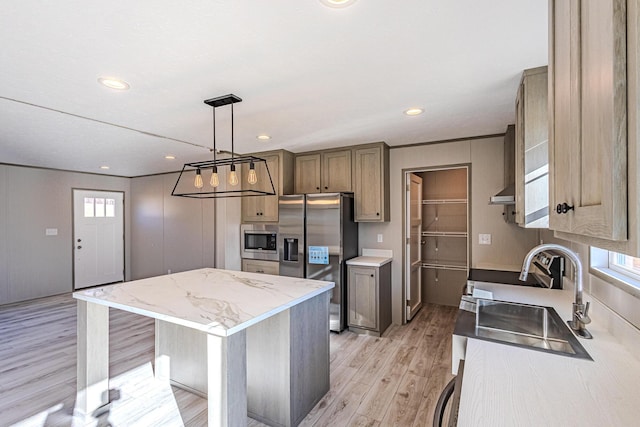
[171,94,276,199]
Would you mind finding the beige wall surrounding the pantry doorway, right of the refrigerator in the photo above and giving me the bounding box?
[359,138,538,324]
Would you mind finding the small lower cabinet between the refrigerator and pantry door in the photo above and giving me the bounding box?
[347,257,391,336]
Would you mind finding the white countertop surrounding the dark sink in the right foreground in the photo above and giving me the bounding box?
[458,284,640,427]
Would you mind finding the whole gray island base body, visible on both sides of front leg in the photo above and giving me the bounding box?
[156,292,331,426]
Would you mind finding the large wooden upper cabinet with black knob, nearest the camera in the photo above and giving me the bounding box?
[549,0,637,241]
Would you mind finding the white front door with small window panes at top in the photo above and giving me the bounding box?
[73,190,124,289]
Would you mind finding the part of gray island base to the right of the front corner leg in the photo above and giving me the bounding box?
[247,292,331,426]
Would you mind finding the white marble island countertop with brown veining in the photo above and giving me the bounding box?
[73,268,335,336]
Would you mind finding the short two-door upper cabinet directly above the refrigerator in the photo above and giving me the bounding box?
[295,149,351,194]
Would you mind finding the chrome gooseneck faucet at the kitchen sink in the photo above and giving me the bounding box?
[520,243,593,339]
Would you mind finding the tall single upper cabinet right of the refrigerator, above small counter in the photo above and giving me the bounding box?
[352,143,390,222]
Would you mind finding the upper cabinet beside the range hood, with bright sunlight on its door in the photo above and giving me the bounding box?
[515,66,549,228]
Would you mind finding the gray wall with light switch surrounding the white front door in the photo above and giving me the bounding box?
[0,164,131,304]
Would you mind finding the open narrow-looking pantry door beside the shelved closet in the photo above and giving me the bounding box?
[405,173,422,322]
